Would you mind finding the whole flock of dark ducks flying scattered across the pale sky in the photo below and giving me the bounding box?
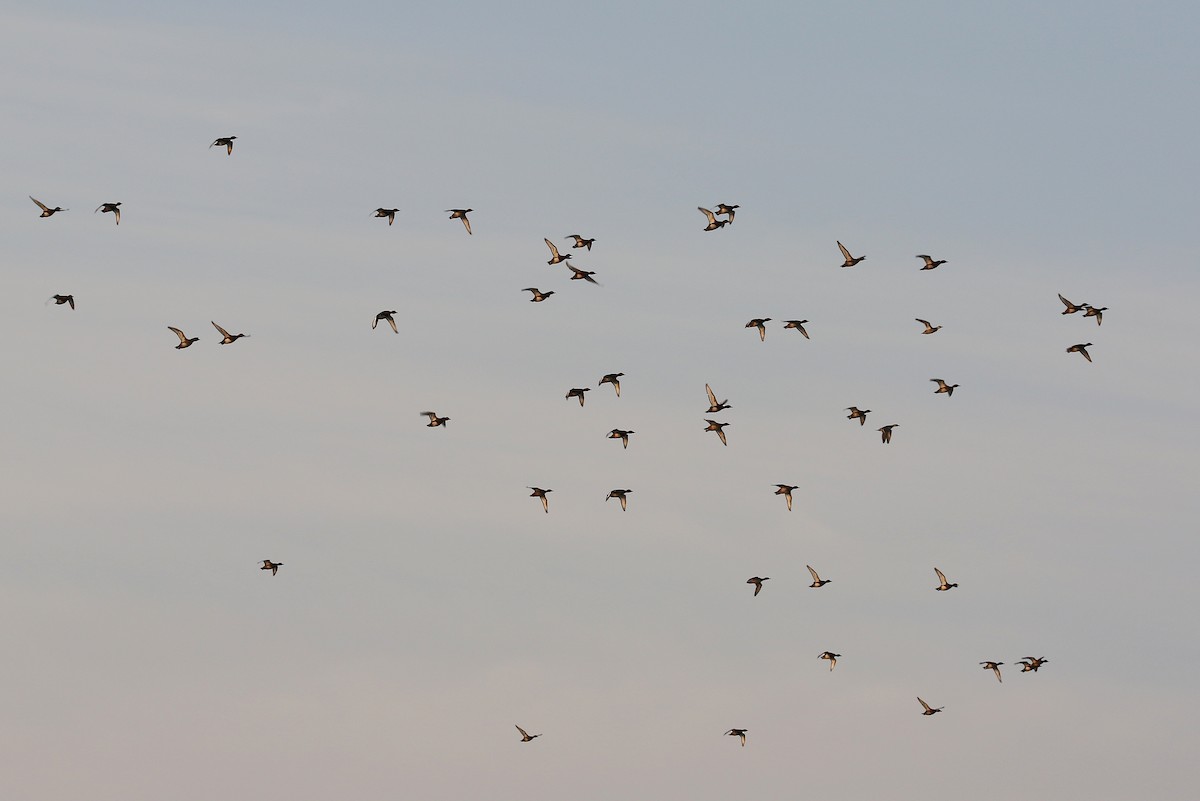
[29,137,1089,747]
